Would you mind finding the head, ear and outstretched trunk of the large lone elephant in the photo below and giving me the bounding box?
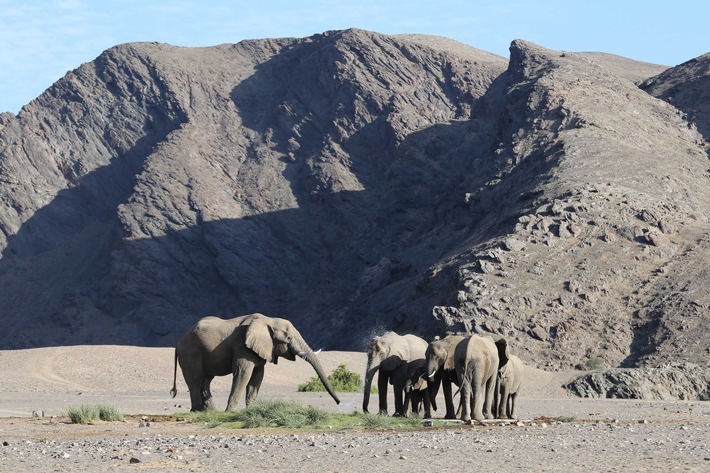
[246,316,340,404]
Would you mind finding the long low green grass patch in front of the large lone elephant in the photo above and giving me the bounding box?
[184,400,443,430]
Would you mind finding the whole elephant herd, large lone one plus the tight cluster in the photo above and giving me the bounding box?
[171,313,523,422]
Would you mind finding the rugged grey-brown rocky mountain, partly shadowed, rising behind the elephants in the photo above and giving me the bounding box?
[0,30,710,390]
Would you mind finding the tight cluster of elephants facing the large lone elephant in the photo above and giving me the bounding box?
[362,332,524,422]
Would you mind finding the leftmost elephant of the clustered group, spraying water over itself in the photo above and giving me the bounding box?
[362,332,427,416]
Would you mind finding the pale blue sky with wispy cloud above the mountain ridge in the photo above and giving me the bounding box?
[0,0,710,113]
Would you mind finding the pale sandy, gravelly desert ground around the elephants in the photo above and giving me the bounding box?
[0,346,710,472]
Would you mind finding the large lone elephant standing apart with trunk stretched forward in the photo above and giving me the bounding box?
[170,313,340,411]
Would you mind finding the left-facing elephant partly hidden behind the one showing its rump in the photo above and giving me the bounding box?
[425,335,468,419]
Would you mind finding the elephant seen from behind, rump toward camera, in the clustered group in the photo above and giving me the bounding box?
[454,335,499,423]
